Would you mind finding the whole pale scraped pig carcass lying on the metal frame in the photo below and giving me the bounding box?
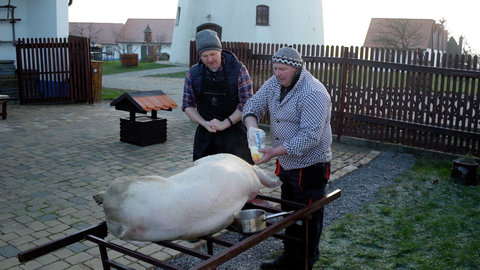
[94,154,280,241]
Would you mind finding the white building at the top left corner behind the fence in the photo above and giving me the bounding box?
[0,0,68,65]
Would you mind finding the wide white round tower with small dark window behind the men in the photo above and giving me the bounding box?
[170,0,323,64]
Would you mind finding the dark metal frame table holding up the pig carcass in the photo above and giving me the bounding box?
[18,189,341,270]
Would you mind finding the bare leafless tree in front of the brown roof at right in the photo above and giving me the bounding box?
[374,19,422,50]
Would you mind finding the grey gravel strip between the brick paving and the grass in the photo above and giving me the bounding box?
[165,152,415,270]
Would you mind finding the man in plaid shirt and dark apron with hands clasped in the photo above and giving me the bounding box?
[182,29,253,164]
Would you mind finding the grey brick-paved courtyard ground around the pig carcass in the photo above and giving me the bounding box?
[0,68,379,269]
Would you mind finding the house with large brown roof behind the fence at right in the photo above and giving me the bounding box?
[363,18,447,53]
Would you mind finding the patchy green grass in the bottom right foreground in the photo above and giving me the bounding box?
[315,158,480,269]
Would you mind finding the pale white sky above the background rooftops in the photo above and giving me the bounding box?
[69,0,480,54]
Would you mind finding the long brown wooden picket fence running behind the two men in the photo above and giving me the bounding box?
[191,42,480,157]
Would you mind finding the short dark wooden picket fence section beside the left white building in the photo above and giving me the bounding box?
[16,36,93,104]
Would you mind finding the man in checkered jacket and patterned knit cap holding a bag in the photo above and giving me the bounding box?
[242,47,332,270]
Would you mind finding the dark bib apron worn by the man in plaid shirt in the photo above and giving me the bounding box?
[193,68,253,164]
